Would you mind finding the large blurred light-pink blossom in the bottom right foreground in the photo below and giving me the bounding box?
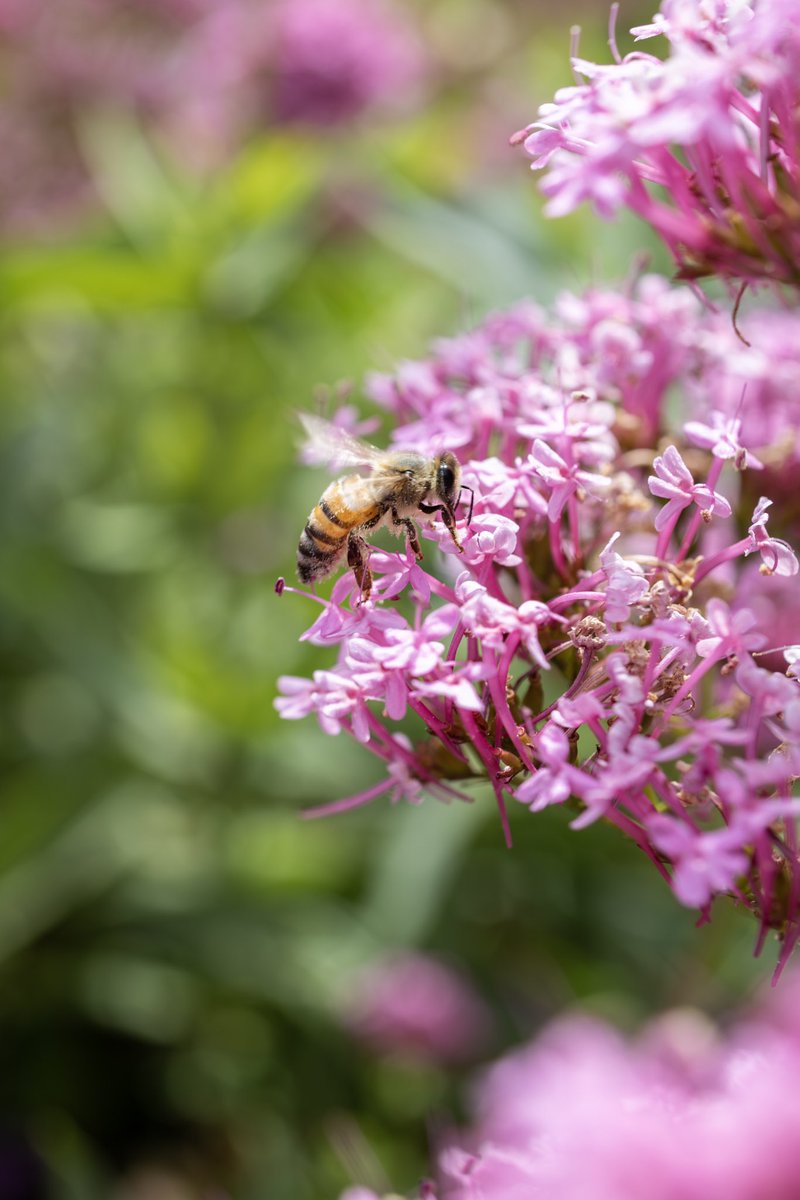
[342,976,800,1200]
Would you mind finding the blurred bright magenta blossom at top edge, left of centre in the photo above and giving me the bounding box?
[168,0,428,160]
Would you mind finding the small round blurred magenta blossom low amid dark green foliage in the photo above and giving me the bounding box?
[345,953,489,1063]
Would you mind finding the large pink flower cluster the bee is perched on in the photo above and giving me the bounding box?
[277,280,800,962]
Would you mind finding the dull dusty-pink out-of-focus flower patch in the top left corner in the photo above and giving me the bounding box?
[0,0,203,233]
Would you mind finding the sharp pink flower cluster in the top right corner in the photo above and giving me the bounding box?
[512,0,800,287]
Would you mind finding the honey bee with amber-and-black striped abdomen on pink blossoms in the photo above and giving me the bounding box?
[297,413,471,604]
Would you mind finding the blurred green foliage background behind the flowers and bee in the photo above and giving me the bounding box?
[0,0,771,1200]
